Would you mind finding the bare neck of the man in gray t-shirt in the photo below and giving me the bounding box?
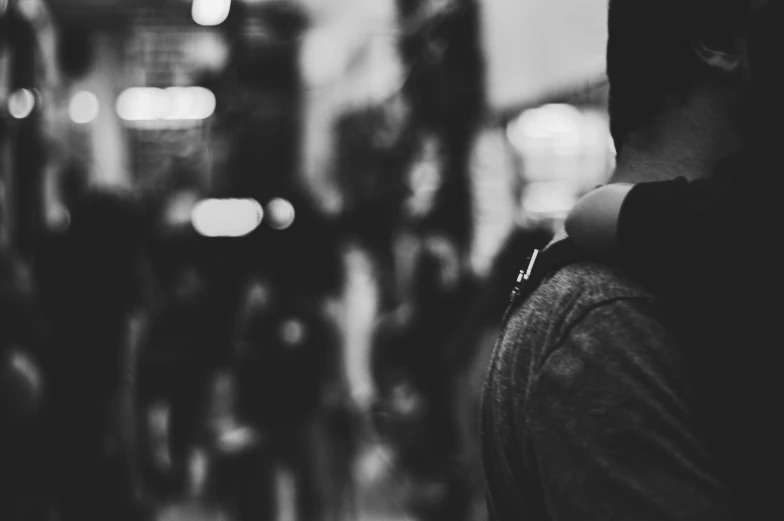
[611,84,741,183]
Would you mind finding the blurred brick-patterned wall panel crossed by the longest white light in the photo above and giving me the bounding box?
[122,9,228,193]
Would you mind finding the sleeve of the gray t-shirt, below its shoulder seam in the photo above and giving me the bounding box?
[517,298,731,521]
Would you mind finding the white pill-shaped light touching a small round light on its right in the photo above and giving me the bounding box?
[191,199,264,237]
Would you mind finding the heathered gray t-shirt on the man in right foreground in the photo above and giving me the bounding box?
[481,263,731,521]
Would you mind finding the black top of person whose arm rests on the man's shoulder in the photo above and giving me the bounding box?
[618,154,784,519]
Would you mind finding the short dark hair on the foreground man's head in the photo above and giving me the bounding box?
[607,0,750,152]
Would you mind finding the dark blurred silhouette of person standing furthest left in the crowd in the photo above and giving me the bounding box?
[36,180,152,521]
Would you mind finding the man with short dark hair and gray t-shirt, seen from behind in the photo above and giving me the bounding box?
[481,0,773,521]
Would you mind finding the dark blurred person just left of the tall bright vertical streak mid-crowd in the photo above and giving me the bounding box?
[220,197,354,521]
